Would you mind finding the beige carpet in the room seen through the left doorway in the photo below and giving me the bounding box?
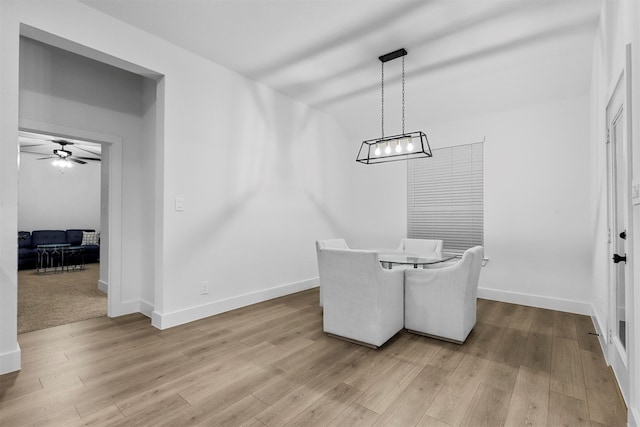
[18,264,107,334]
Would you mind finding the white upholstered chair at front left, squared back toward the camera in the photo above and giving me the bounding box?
[318,248,404,348]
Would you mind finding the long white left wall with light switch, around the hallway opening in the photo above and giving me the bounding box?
[0,1,355,371]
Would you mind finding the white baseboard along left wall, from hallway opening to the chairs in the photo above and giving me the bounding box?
[151,277,318,329]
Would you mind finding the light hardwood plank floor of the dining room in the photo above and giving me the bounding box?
[0,289,626,426]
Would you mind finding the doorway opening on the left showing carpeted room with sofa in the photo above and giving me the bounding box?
[18,131,108,334]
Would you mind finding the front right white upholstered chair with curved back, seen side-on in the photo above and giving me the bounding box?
[404,246,484,344]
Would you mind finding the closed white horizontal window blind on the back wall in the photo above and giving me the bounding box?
[407,142,484,253]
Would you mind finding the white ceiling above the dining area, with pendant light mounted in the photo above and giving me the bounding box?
[82,0,601,140]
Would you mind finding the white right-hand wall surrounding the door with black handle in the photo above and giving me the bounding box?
[590,1,640,426]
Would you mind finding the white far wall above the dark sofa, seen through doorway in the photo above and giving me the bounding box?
[18,155,100,231]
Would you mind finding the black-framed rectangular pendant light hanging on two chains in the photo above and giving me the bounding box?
[356,49,432,165]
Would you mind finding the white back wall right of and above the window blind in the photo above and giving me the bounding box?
[422,97,591,314]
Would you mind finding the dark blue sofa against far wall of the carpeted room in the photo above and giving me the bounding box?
[18,228,100,270]
